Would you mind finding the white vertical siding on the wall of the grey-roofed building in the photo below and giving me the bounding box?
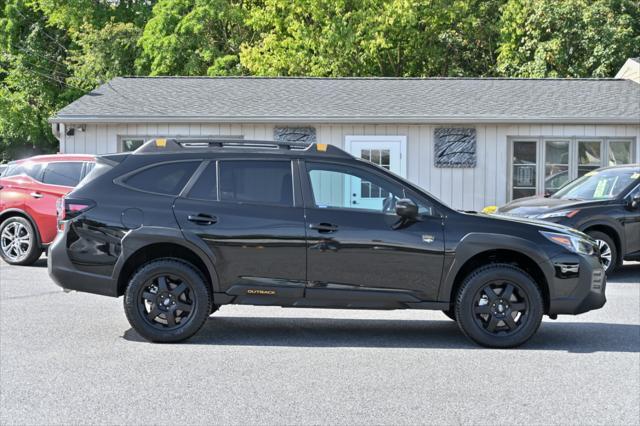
[60,123,640,210]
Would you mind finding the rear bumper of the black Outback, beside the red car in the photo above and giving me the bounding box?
[47,232,118,297]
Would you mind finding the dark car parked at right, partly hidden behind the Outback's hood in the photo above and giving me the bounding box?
[495,164,640,273]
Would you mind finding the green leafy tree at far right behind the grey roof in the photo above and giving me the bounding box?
[498,0,640,77]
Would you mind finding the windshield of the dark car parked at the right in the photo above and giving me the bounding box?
[551,168,640,200]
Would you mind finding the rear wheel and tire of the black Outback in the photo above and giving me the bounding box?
[124,258,213,343]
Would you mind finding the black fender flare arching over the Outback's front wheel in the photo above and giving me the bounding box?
[438,232,555,302]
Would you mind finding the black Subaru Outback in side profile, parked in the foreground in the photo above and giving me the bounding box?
[49,139,606,347]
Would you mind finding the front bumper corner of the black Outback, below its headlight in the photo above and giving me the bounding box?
[548,254,607,315]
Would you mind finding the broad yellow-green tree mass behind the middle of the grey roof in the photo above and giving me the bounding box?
[241,0,504,76]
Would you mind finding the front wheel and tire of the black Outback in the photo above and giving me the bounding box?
[455,263,544,348]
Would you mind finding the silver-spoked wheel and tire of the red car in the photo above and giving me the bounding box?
[0,216,42,265]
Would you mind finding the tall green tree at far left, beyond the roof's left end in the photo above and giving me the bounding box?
[0,0,75,157]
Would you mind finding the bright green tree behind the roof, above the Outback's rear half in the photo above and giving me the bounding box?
[138,0,252,75]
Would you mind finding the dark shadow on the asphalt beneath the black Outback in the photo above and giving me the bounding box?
[123,315,640,353]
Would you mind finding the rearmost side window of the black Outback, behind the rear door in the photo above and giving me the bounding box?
[124,161,199,195]
